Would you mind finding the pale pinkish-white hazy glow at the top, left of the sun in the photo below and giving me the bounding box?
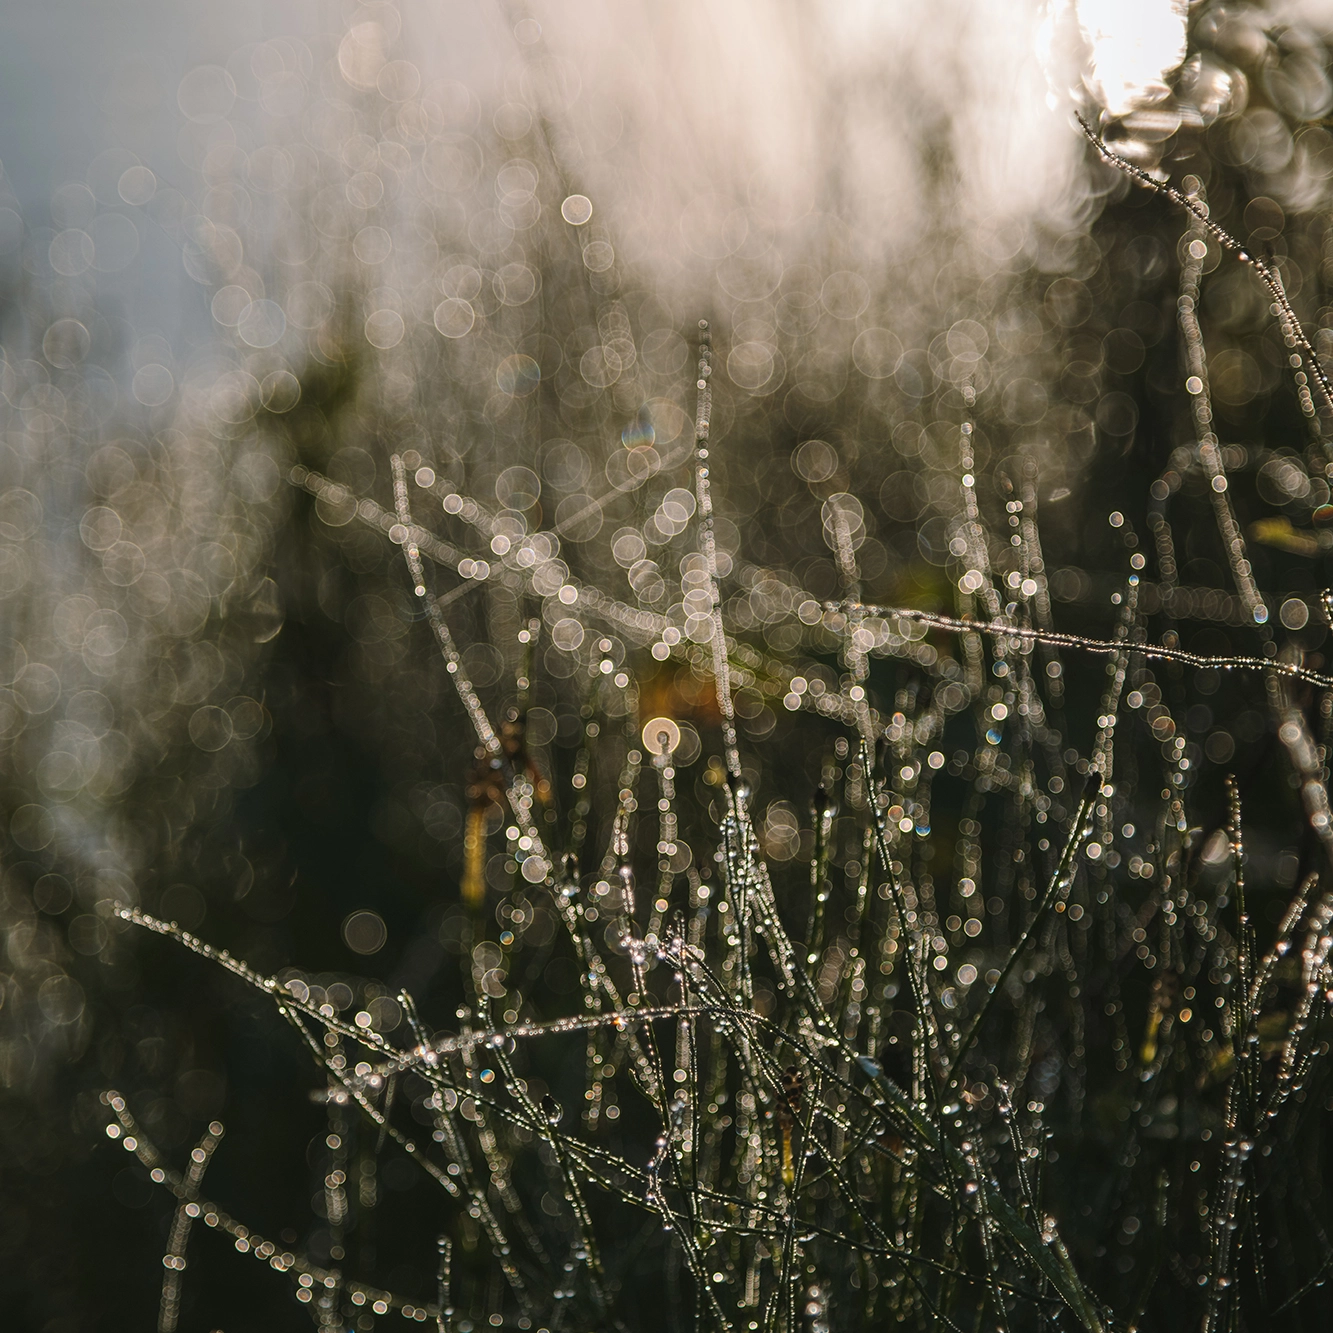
[437,0,1081,281]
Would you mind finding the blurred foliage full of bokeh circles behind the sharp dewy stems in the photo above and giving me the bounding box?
[0,0,1333,1333]
